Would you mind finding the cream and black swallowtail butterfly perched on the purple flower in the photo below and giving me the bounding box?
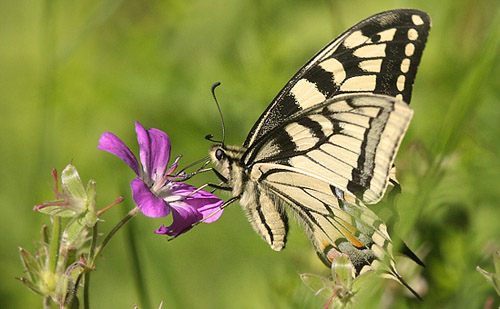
[210,9,431,297]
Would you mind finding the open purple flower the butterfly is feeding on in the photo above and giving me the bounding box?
[97,122,223,236]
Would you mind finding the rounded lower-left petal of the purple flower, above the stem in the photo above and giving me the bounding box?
[130,177,170,217]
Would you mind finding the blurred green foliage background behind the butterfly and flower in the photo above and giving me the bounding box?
[0,0,500,308]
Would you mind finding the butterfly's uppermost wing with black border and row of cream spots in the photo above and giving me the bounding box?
[244,9,431,147]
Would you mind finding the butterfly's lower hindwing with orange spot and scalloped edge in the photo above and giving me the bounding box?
[261,167,390,273]
